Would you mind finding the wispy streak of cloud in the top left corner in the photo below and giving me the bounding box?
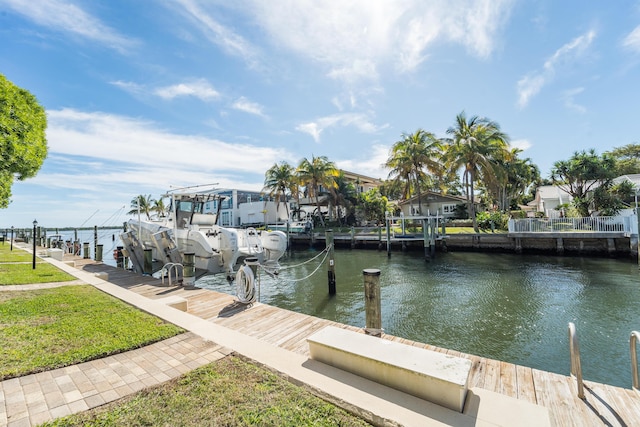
[2,0,138,53]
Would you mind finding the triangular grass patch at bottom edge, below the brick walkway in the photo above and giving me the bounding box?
[44,356,369,427]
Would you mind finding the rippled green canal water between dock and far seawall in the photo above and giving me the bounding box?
[197,250,640,388]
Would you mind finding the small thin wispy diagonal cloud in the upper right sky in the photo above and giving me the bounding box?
[517,30,596,108]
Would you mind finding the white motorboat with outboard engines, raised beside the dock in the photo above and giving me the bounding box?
[121,192,287,279]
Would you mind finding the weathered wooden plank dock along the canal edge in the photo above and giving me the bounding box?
[76,262,640,427]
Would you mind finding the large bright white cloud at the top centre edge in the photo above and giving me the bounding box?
[245,0,514,83]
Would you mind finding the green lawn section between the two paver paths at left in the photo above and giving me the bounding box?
[0,286,183,379]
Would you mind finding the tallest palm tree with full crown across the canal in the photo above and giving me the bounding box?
[443,112,509,232]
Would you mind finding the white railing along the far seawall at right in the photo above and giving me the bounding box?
[509,215,638,235]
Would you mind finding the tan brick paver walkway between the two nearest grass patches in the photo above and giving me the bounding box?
[0,332,231,427]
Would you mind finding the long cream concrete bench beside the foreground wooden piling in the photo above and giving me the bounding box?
[307,326,471,412]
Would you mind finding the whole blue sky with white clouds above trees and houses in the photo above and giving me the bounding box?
[0,0,640,227]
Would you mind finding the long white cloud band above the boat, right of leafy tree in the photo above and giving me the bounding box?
[47,109,291,180]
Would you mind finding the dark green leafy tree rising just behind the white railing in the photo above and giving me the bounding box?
[551,149,616,217]
